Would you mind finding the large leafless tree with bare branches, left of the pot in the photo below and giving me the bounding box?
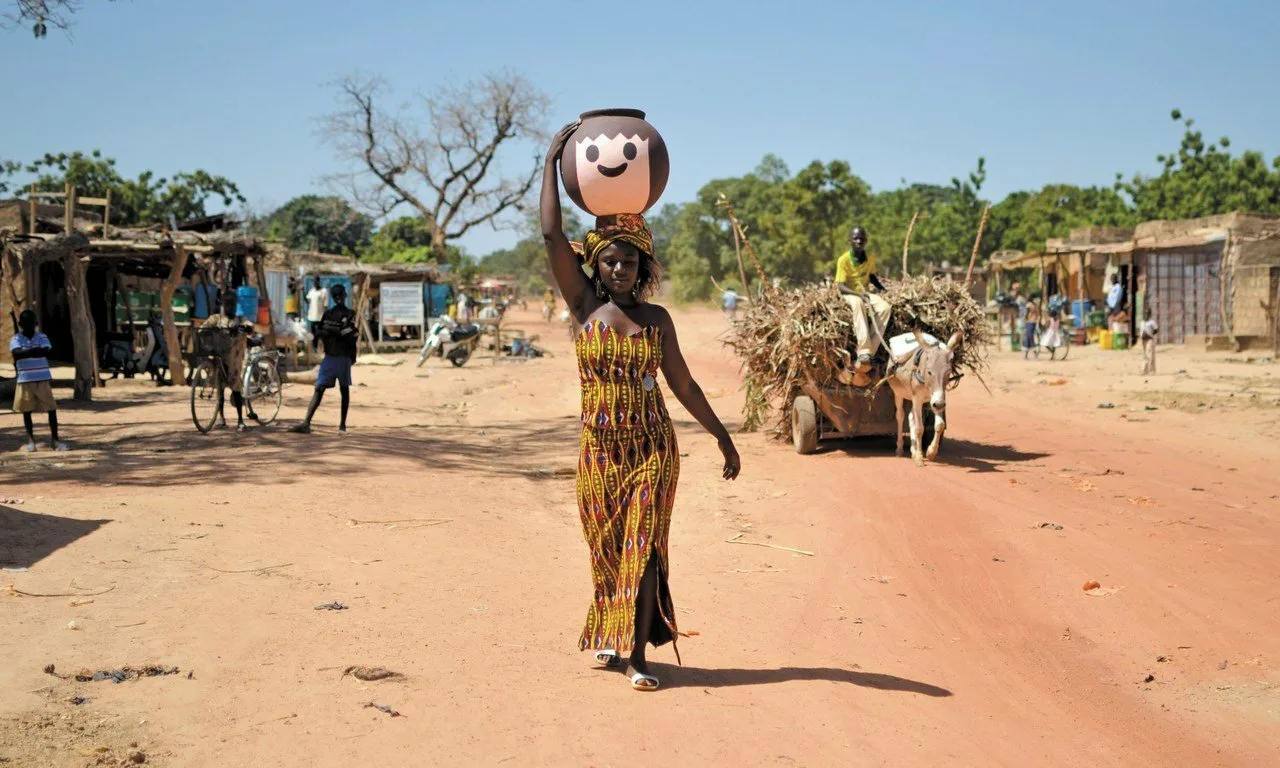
[323,73,548,252]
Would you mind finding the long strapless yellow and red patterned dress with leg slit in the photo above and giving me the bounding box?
[575,321,680,660]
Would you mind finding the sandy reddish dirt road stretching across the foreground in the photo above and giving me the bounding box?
[0,304,1280,767]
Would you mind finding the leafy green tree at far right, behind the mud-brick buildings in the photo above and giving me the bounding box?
[1116,109,1280,220]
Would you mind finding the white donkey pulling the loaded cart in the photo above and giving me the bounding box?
[884,330,960,467]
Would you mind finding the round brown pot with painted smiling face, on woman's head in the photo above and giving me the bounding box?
[561,109,671,216]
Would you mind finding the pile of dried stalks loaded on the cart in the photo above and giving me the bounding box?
[726,276,988,438]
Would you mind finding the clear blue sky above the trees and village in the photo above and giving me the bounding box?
[0,0,1280,253]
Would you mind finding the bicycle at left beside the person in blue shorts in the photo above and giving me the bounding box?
[191,328,284,434]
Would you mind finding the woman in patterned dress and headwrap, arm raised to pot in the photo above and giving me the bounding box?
[541,123,741,691]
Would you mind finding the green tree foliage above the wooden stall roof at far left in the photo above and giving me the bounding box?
[0,150,244,227]
